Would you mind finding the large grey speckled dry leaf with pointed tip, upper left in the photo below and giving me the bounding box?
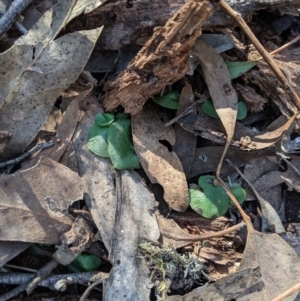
[0,0,102,159]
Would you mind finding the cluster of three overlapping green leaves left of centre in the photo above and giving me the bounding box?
[87,113,140,170]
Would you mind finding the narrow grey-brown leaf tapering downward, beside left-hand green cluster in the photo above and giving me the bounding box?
[72,96,116,252]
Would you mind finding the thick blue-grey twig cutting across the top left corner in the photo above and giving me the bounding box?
[0,0,32,39]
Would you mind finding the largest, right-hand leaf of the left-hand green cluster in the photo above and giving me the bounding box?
[107,120,140,170]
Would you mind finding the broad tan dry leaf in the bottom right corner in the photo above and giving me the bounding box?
[236,230,300,301]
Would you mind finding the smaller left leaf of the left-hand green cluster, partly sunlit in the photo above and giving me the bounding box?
[87,125,109,157]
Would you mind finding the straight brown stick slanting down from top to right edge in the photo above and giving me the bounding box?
[219,0,300,109]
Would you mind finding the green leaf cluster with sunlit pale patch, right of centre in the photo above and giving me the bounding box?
[189,176,246,218]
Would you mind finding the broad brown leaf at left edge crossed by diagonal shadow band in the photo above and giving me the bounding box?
[0,157,83,244]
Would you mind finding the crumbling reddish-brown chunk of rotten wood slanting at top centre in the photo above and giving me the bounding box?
[103,0,214,114]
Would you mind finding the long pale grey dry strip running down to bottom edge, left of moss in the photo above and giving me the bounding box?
[105,170,160,301]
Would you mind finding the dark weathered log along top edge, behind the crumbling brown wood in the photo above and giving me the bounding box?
[66,0,298,52]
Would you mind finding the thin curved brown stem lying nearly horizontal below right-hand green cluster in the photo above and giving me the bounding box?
[160,222,245,241]
